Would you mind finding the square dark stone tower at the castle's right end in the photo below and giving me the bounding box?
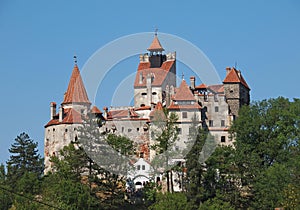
[223,67,250,117]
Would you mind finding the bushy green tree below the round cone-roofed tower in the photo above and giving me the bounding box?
[42,144,101,209]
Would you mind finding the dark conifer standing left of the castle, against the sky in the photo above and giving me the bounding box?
[2,133,43,209]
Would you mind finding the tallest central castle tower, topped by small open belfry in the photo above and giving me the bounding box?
[134,33,176,108]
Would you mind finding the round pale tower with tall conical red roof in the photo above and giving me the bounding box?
[44,61,102,174]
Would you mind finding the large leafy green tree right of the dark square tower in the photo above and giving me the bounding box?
[231,97,300,208]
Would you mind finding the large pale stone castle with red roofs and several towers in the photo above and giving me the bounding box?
[44,34,250,189]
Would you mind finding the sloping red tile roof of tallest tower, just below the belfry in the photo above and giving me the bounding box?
[134,61,175,87]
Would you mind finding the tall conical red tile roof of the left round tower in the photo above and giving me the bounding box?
[62,65,91,104]
